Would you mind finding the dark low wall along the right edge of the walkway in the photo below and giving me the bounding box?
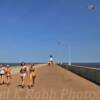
[58,64,100,85]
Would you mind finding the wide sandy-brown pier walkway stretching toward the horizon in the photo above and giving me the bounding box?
[0,65,100,100]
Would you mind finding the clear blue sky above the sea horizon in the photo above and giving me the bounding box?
[0,0,100,62]
